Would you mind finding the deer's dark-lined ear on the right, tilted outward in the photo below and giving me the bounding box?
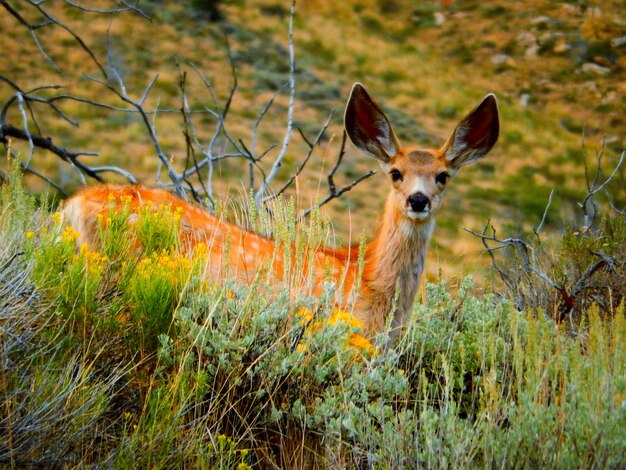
[442,94,500,169]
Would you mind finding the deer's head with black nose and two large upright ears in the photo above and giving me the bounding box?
[345,83,500,224]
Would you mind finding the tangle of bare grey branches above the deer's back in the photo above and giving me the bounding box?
[0,0,374,224]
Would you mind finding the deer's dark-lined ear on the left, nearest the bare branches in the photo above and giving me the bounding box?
[344,83,400,163]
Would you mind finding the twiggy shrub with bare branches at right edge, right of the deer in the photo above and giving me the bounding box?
[465,147,626,334]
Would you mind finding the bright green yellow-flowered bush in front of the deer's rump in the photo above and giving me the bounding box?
[25,196,198,353]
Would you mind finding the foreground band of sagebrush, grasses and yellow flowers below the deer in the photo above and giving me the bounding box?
[0,168,626,469]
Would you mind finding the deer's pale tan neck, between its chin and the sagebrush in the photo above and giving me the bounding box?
[365,194,435,334]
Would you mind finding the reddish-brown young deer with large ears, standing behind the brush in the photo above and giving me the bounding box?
[63,83,499,335]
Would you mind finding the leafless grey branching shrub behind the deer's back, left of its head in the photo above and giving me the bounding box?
[0,0,374,220]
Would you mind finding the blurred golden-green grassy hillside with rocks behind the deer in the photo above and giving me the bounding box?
[0,0,626,278]
